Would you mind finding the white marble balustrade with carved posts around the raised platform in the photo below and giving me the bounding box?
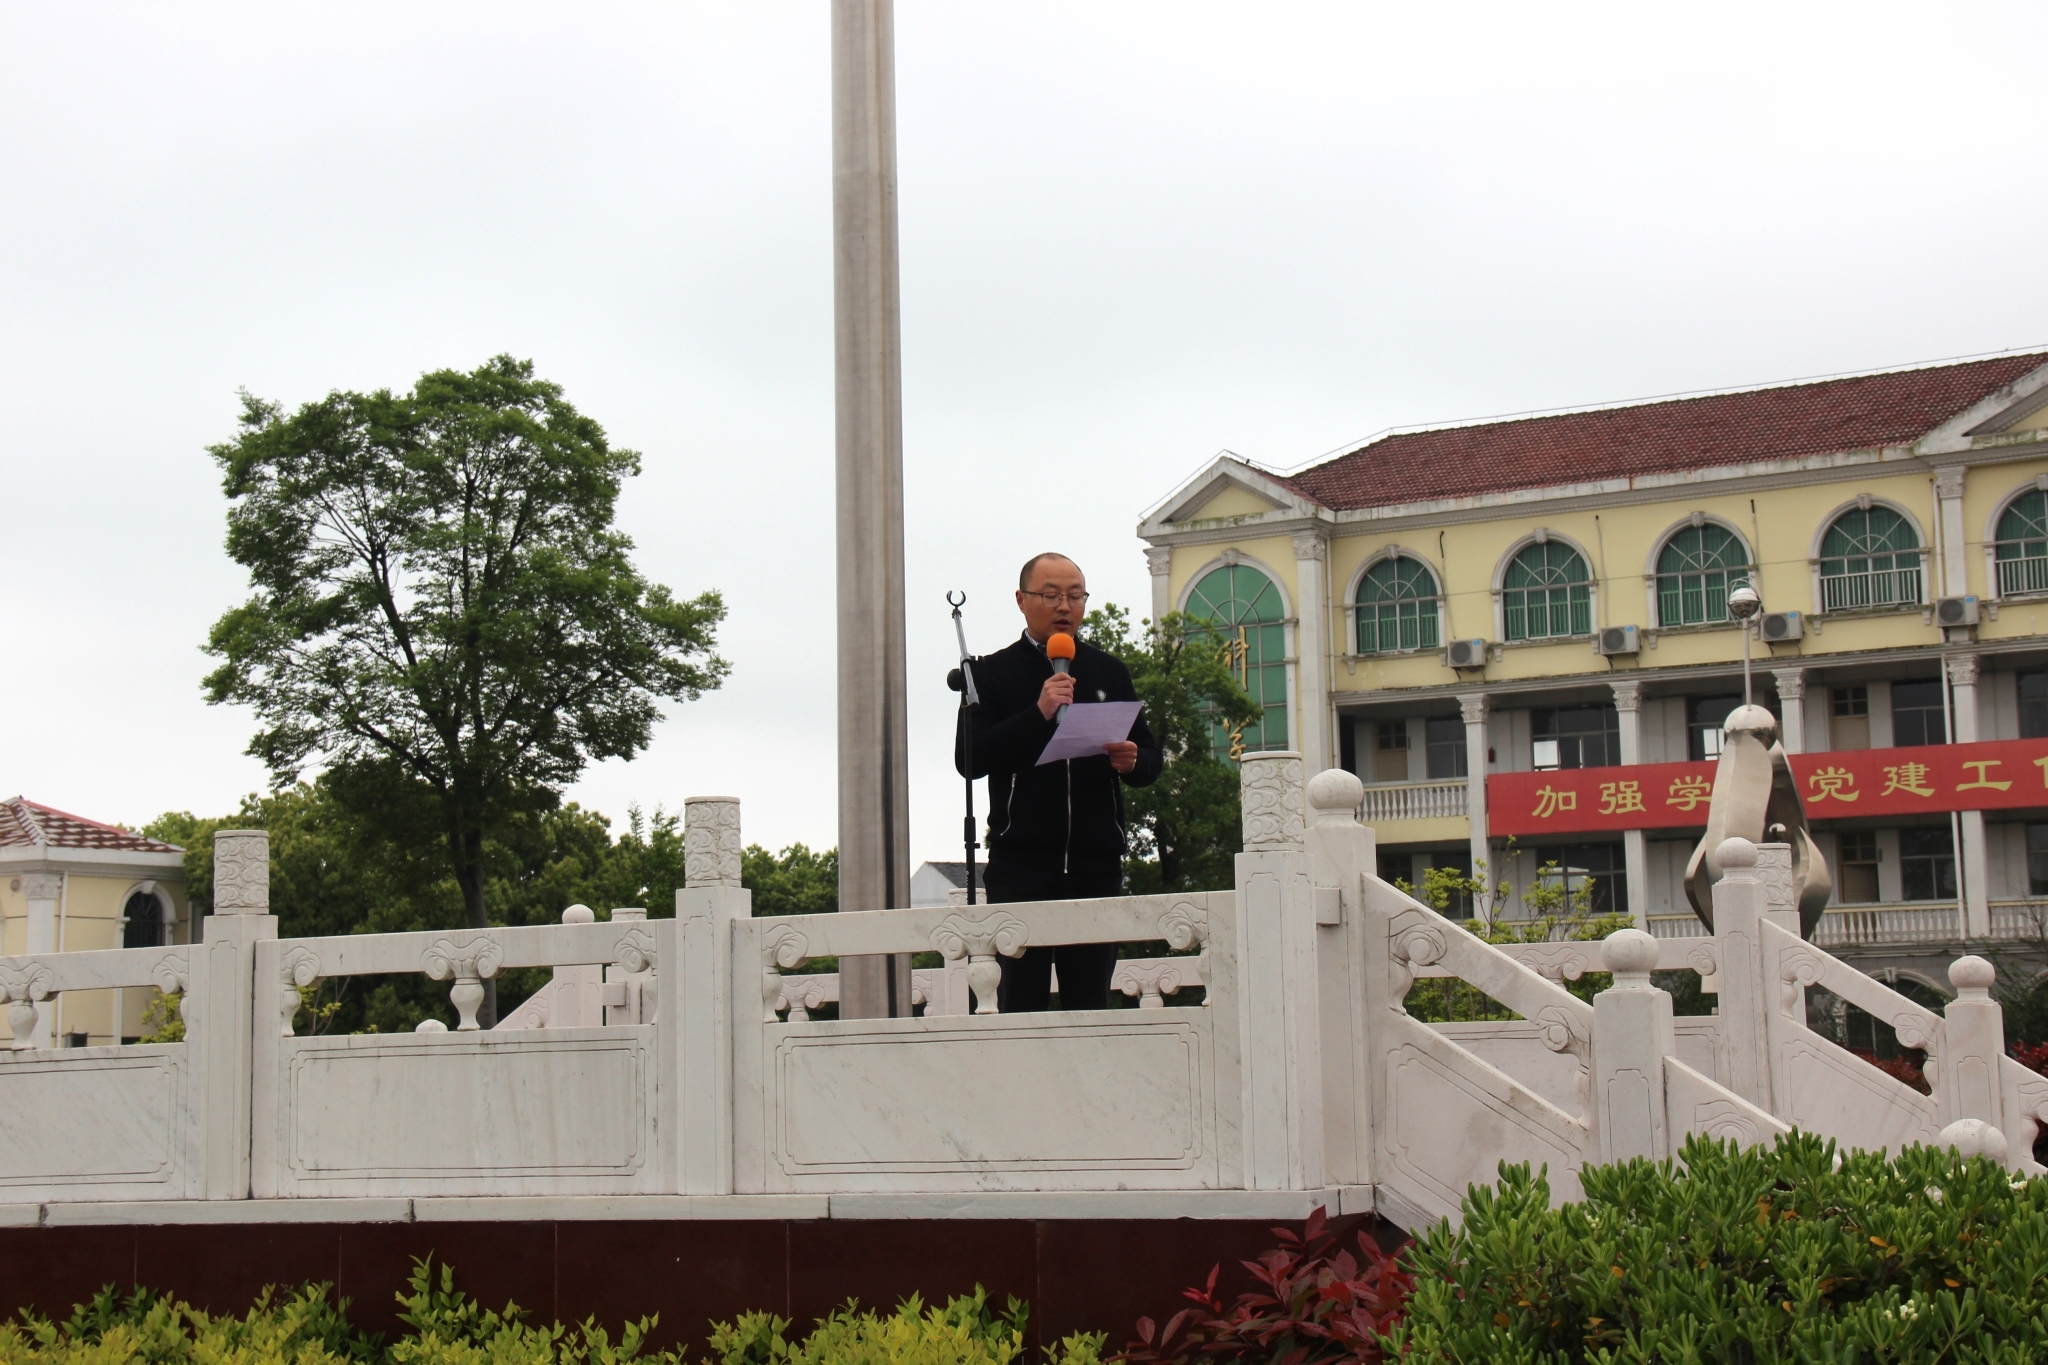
[0,769,2048,1226]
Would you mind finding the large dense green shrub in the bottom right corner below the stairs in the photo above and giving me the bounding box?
[1386,1134,2048,1365]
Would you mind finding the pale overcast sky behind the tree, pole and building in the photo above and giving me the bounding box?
[0,0,2048,860]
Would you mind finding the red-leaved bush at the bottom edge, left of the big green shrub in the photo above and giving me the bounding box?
[1110,1209,1415,1365]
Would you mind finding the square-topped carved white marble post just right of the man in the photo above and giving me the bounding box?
[1237,753,1327,1189]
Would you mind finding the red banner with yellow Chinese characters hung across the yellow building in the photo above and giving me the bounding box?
[1487,739,2048,837]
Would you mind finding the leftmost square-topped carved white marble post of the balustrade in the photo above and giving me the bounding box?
[184,829,276,1199]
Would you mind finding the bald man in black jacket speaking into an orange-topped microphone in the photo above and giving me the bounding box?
[954,555,1161,1013]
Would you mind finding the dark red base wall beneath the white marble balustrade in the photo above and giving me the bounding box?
[0,1218,1399,1349]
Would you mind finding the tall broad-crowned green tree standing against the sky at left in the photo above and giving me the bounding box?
[207,356,727,1021]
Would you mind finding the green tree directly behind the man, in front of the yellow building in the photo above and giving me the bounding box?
[1083,604,1262,894]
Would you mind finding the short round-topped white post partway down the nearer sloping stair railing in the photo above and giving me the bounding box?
[1589,929,1671,1162]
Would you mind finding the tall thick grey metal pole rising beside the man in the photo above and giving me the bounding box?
[831,0,909,1019]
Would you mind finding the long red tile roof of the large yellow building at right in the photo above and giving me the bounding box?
[1282,352,2048,508]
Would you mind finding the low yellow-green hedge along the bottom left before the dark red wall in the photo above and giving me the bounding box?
[0,1263,1102,1365]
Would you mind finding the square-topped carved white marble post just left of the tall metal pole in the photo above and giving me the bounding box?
[679,796,745,1195]
